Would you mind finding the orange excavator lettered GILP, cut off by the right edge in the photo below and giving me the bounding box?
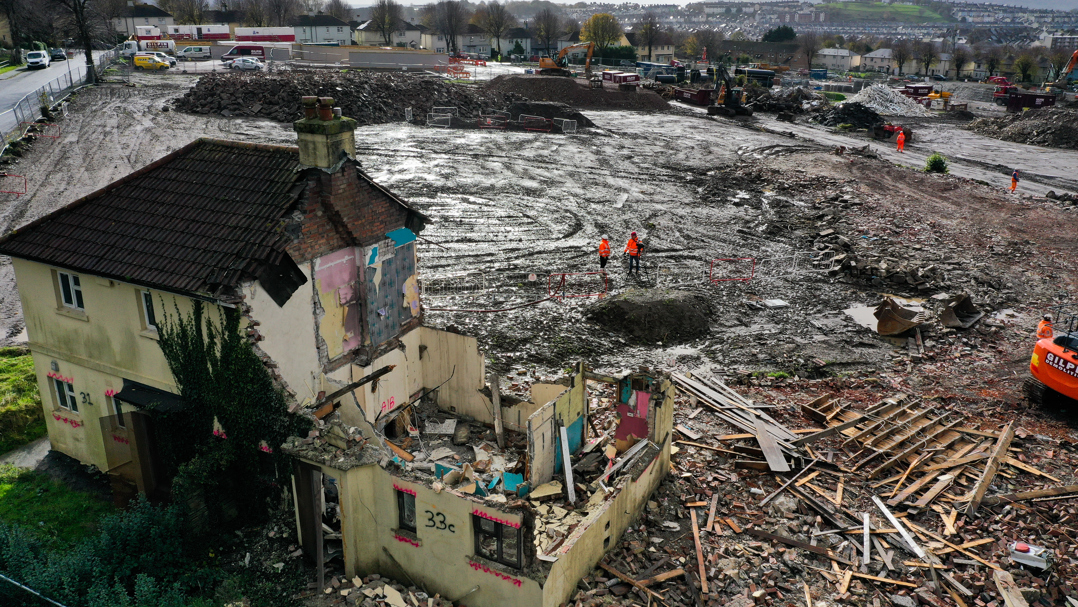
[1023,308,1078,406]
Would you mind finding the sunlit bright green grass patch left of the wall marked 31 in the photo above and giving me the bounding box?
[0,348,45,454]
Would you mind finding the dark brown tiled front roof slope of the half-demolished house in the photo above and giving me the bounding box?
[0,139,305,295]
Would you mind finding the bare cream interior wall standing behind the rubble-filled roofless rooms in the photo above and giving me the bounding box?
[418,327,494,424]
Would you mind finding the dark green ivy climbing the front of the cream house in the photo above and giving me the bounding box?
[154,302,310,527]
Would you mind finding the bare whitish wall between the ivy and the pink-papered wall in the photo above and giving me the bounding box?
[241,264,320,402]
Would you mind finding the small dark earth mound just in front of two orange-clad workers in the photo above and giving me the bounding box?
[588,289,709,344]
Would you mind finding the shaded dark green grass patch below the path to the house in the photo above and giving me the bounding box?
[0,466,113,548]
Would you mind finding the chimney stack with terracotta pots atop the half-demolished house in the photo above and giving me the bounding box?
[292,97,356,168]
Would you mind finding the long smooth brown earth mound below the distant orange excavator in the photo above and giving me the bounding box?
[485,75,669,110]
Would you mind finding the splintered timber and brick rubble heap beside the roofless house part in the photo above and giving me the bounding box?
[576,374,1078,607]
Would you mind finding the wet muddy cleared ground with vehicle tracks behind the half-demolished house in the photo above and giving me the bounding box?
[0,70,1078,603]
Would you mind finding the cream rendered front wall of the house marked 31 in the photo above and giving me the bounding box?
[12,259,203,470]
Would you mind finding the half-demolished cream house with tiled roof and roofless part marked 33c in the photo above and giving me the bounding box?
[0,98,675,606]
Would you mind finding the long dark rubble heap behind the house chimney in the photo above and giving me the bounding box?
[175,70,523,125]
